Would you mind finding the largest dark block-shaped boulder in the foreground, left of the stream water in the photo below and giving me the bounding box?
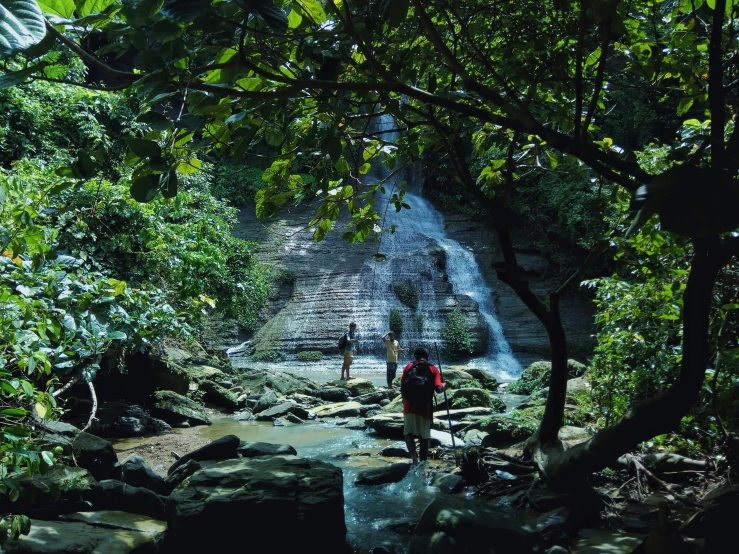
[168,456,346,553]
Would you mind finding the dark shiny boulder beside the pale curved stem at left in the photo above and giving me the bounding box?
[90,400,171,438]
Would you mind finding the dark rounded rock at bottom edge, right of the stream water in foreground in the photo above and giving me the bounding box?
[408,496,534,554]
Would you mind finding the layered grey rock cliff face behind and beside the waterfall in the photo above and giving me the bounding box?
[235,192,594,369]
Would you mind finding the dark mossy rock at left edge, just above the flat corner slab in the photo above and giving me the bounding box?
[0,466,98,517]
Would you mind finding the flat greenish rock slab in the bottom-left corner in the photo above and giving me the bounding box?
[2,511,167,554]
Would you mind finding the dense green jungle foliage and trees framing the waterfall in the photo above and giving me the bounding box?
[0,0,739,520]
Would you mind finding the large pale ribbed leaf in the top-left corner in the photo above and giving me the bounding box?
[0,0,46,59]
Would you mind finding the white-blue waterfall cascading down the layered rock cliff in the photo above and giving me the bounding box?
[355,115,522,378]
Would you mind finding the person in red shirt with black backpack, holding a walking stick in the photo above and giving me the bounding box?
[400,348,444,464]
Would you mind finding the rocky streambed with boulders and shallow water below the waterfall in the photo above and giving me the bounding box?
[3,349,700,553]
